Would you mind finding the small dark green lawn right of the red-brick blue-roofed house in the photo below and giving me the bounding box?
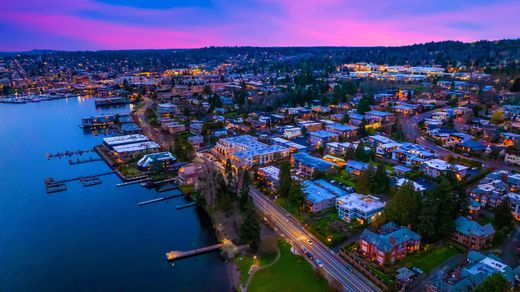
[402,244,460,273]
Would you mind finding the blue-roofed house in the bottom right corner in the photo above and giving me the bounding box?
[425,251,515,292]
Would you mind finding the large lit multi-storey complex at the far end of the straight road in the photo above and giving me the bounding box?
[211,135,290,169]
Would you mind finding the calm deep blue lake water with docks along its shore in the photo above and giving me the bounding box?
[0,98,230,291]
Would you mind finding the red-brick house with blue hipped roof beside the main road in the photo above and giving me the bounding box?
[359,222,421,265]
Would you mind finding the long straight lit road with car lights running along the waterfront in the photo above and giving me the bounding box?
[250,186,380,291]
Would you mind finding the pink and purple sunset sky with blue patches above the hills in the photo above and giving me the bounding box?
[0,0,520,51]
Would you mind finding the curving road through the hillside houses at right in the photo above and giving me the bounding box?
[401,111,518,171]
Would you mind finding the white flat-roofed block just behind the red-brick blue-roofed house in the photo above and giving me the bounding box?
[336,193,385,224]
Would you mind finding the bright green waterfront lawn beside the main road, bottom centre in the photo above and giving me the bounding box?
[248,243,330,292]
